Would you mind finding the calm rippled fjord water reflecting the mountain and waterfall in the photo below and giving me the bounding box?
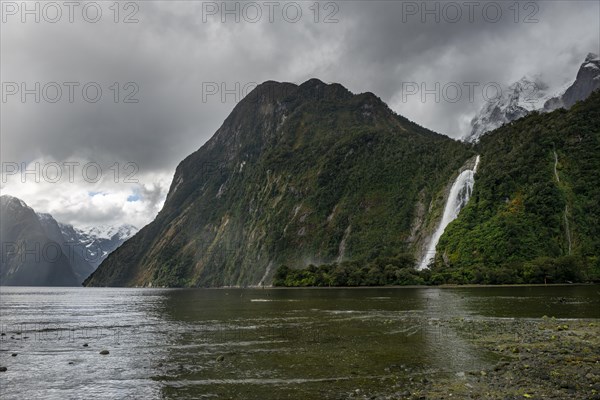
[0,286,600,399]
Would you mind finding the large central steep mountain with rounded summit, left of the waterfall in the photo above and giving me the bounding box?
[84,79,475,286]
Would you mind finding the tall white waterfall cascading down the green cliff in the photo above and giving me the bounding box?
[417,156,479,270]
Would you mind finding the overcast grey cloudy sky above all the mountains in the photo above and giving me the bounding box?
[0,0,600,227]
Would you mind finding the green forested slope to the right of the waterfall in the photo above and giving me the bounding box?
[434,91,600,283]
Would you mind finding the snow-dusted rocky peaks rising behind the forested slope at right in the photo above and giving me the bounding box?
[464,53,600,142]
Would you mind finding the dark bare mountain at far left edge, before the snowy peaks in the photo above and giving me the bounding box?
[0,195,80,286]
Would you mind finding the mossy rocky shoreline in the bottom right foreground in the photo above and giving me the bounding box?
[360,316,600,400]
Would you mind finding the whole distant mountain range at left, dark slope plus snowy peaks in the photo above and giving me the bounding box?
[0,195,137,286]
